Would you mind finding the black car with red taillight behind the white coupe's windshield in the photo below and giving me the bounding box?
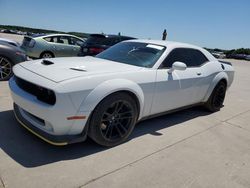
[78,34,135,56]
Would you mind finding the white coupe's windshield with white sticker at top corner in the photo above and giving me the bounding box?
[96,42,166,67]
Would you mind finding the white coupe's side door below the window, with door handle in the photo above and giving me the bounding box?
[151,67,205,114]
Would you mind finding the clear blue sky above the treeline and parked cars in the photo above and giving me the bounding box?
[0,0,250,49]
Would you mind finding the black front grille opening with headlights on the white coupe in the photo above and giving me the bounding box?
[14,76,56,105]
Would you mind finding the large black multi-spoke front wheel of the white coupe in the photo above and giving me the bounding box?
[88,92,138,147]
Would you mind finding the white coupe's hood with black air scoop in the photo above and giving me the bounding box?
[19,56,141,82]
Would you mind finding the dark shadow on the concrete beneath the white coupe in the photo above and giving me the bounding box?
[0,107,208,168]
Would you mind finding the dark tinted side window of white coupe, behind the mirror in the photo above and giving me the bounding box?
[161,48,208,68]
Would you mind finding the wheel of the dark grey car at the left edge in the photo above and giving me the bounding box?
[0,56,14,81]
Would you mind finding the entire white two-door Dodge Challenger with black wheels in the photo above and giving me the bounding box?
[9,40,234,146]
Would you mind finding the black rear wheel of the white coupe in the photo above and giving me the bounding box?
[205,81,227,112]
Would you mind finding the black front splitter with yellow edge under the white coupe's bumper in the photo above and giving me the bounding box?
[14,103,87,146]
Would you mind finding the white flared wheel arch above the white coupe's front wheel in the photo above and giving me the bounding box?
[80,79,144,118]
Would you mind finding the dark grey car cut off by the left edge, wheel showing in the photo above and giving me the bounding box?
[0,41,27,81]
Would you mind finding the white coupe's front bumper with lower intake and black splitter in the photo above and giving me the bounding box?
[9,75,90,145]
